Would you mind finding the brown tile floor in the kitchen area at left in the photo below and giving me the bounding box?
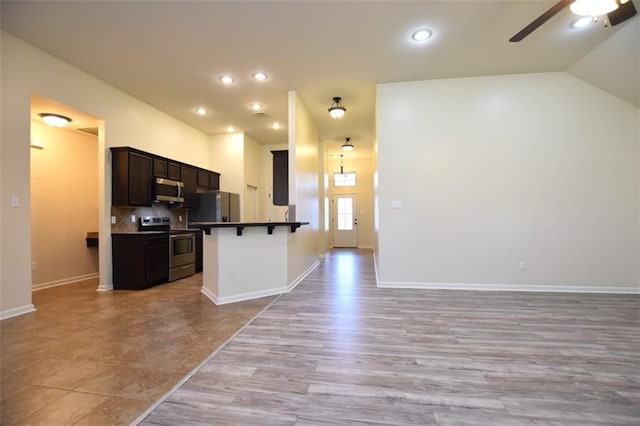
[0,274,274,426]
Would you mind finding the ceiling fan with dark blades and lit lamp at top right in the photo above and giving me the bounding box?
[509,0,636,43]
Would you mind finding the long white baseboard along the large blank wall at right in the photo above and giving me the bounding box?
[374,282,640,294]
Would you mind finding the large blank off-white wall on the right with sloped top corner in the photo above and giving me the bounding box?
[377,73,640,291]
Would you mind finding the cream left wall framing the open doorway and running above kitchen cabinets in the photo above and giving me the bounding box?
[0,32,210,317]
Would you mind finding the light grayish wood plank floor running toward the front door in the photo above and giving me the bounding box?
[141,251,640,426]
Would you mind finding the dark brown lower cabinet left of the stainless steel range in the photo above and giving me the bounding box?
[111,233,169,290]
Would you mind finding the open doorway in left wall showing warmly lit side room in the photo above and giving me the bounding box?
[30,94,101,290]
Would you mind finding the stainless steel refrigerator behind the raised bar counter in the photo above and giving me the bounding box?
[188,191,240,223]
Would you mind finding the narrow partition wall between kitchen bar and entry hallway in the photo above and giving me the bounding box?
[287,91,322,283]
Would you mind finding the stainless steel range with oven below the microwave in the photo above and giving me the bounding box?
[138,216,196,281]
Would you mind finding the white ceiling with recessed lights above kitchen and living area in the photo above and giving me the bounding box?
[0,0,640,156]
